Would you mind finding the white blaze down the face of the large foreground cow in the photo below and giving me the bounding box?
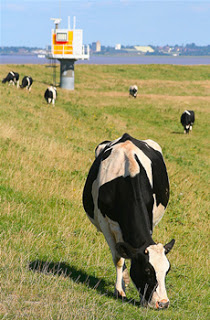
[147,243,170,308]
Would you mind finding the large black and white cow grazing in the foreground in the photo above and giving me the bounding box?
[83,134,175,309]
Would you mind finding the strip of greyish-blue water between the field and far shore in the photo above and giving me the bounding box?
[0,55,210,65]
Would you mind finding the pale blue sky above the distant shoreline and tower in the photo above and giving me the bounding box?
[0,0,210,48]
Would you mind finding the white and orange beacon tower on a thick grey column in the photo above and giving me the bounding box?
[47,17,90,90]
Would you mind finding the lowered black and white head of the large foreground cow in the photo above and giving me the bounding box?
[116,239,175,309]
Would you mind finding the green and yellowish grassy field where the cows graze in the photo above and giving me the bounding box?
[0,61,210,320]
